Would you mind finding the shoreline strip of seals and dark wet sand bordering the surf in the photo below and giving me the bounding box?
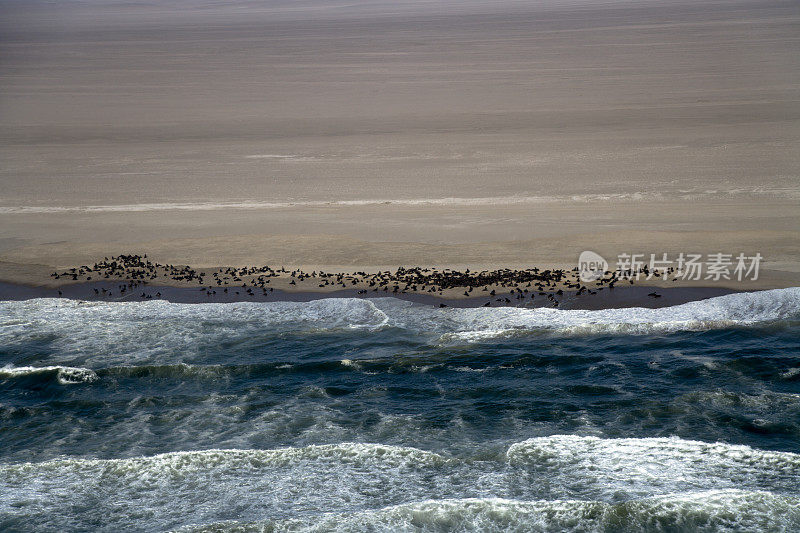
[0,254,789,310]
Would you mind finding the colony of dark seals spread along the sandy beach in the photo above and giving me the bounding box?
[43,254,674,307]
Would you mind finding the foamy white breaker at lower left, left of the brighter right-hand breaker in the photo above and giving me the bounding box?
[0,443,452,531]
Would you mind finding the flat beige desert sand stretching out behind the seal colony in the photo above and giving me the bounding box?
[0,0,800,288]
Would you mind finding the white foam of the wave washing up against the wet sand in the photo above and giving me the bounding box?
[0,287,800,367]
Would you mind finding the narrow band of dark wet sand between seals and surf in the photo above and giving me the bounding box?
[0,281,753,310]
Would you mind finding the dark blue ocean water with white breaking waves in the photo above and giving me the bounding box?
[0,288,800,532]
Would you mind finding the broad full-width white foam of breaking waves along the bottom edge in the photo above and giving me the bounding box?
[0,436,800,531]
